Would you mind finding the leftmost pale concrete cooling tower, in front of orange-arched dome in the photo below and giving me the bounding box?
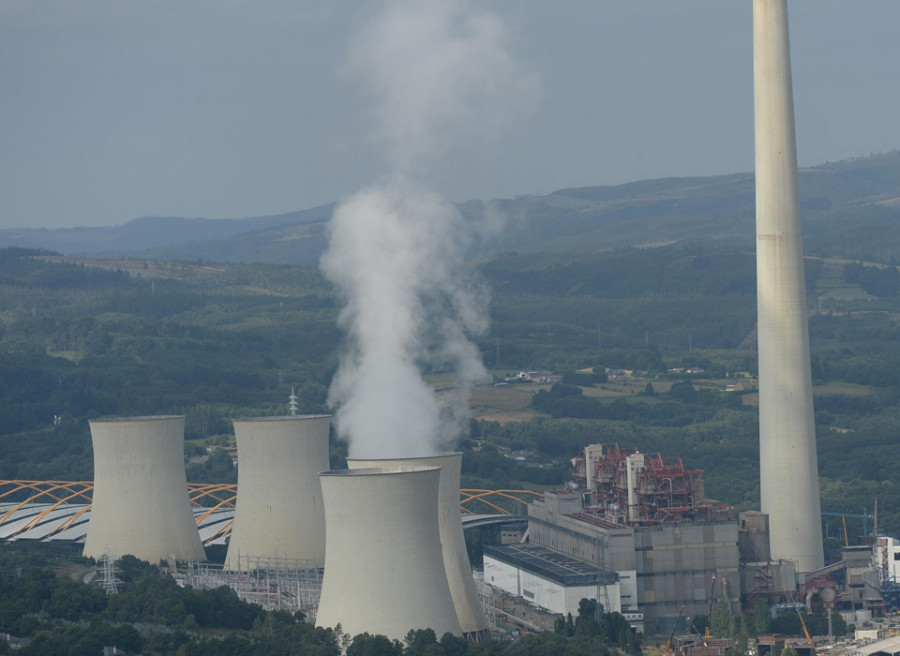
[84,416,206,564]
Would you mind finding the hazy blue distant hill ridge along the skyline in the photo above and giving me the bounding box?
[0,150,900,264]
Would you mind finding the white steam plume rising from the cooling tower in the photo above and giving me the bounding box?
[321,0,536,457]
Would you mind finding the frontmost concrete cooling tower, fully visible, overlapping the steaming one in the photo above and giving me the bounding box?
[316,467,462,640]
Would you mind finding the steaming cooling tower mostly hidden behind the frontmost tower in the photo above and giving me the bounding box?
[347,453,490,642]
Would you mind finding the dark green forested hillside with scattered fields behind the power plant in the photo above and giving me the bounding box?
[0,242,900,532]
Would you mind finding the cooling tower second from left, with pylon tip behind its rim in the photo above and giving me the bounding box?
[225,415,331,570]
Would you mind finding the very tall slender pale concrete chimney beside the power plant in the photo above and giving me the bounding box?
[753,0,824,572]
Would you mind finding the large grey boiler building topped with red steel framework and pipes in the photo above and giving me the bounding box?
[528,444,741,632]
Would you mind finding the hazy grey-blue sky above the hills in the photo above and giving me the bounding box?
[0,0,900,228]
